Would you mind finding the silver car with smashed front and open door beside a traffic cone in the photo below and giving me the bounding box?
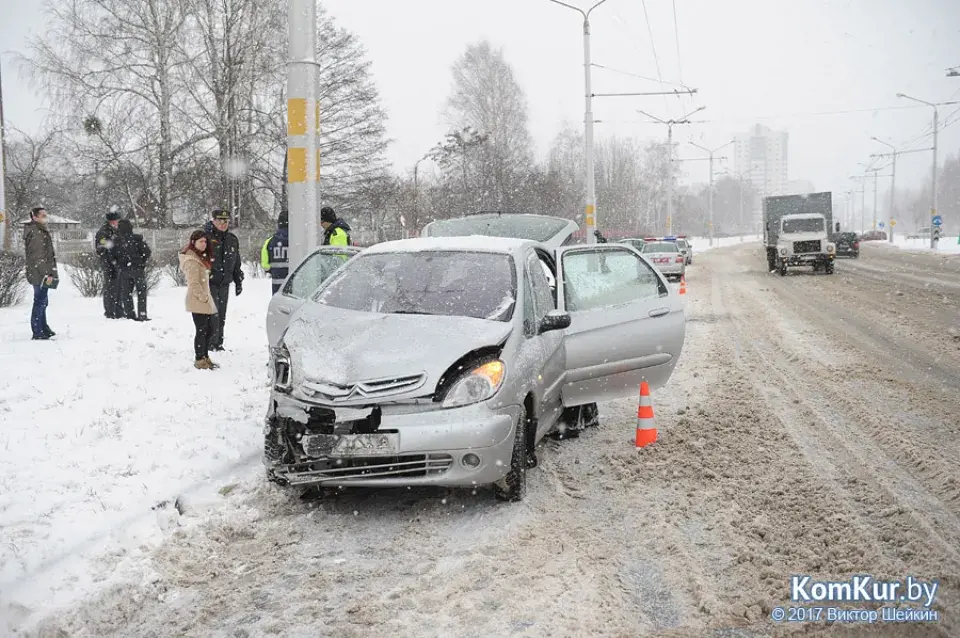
[264,236,685,501]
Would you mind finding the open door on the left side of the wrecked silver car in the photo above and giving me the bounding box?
[267,246,360,346]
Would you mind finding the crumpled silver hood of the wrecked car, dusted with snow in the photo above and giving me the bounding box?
[283,303,512,396]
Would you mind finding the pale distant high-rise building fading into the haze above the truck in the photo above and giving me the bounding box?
[734,124,787,226]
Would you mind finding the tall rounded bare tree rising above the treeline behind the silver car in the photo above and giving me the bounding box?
[447,41,533,207]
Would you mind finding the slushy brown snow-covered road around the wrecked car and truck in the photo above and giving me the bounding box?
[11,244,960,637]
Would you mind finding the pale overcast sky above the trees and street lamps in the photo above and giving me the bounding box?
[0,0,960,199]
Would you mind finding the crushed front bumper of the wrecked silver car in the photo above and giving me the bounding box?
[263,395,520,487]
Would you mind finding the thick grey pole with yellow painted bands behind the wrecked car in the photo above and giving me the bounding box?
[287,0,320,268]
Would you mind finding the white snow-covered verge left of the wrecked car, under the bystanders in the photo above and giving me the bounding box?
[0,268,270,634]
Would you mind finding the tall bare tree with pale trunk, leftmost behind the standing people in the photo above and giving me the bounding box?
[29,0,209,228]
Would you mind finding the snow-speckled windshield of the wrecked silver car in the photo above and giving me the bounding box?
[315,251,517,321]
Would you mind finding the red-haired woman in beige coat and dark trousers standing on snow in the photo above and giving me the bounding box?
[180,230,220,370]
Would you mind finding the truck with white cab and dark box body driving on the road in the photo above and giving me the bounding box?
[763,193,840,276]
